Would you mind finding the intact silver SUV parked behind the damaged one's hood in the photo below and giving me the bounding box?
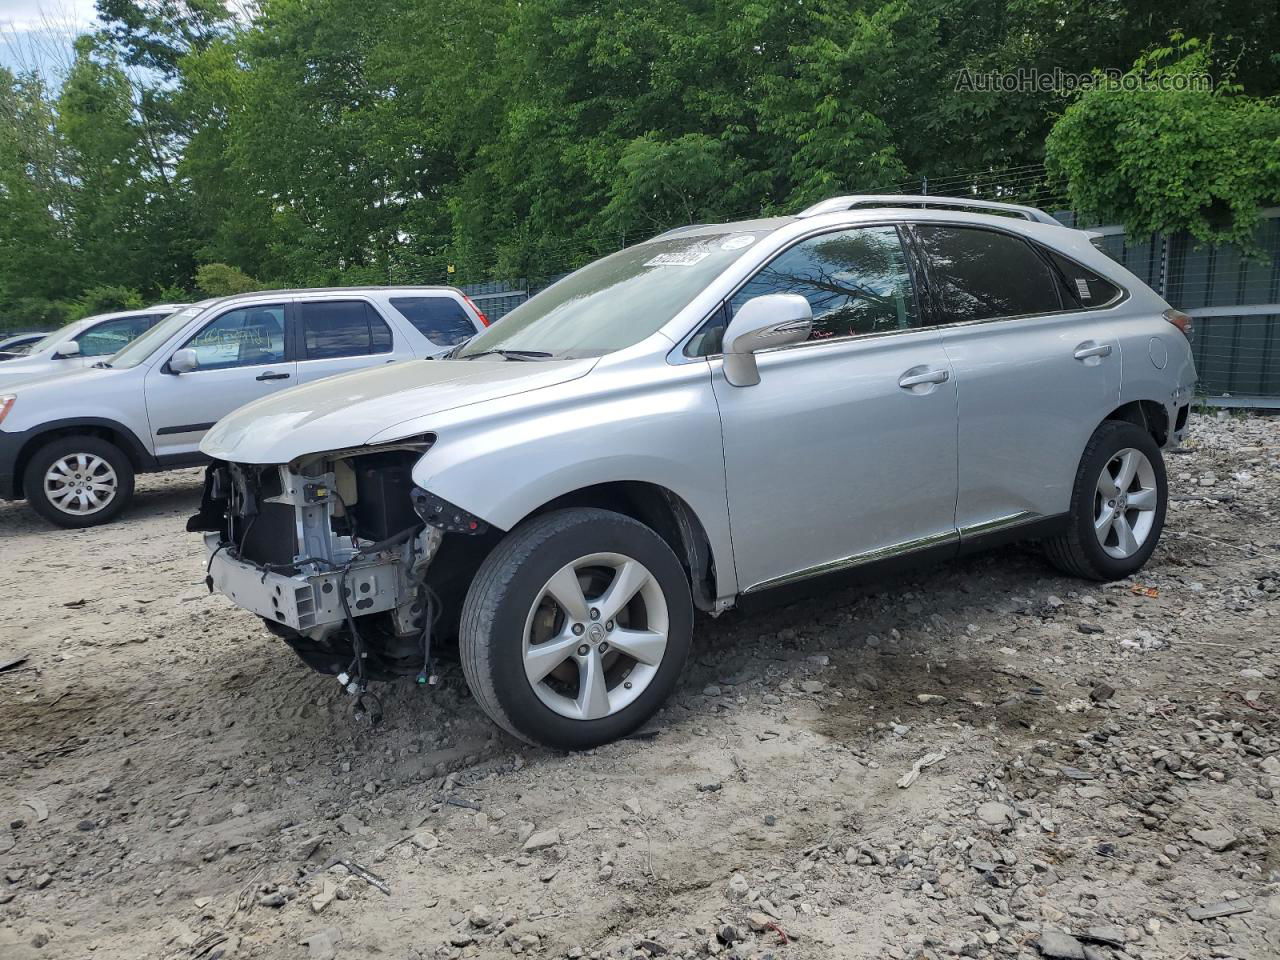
[0,287,488,527]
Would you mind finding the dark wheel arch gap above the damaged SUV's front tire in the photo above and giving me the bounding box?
[513,480,728,612]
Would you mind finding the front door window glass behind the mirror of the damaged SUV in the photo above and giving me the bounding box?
[730,227,918,340]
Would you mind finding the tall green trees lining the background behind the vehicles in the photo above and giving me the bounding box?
[0,0,1280,323]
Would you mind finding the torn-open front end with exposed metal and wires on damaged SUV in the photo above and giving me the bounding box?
[187,436,500,694]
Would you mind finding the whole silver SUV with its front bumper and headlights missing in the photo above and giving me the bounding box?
[189,197,1196,749]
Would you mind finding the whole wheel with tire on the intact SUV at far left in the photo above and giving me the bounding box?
[22,436,133,527]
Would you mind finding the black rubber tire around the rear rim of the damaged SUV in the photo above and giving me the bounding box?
[1043,420,1169,580]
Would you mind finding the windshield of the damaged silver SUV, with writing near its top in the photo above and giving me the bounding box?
[454,221,778,358]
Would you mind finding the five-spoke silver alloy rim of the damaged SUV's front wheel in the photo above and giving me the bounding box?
[522,553,669,721]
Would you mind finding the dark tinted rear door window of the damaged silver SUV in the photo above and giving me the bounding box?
[915,224,1062,324]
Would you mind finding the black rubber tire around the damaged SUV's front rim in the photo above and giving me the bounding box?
[458,508,694,750]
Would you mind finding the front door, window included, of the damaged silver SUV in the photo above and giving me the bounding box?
[712,227,956,593]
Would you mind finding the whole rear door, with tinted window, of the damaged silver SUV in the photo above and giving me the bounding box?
[913,223,1120,540]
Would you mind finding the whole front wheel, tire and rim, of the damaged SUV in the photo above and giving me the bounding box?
[460,509,694,750]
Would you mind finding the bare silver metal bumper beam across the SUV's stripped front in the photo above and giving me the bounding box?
[205,532,404,634]
